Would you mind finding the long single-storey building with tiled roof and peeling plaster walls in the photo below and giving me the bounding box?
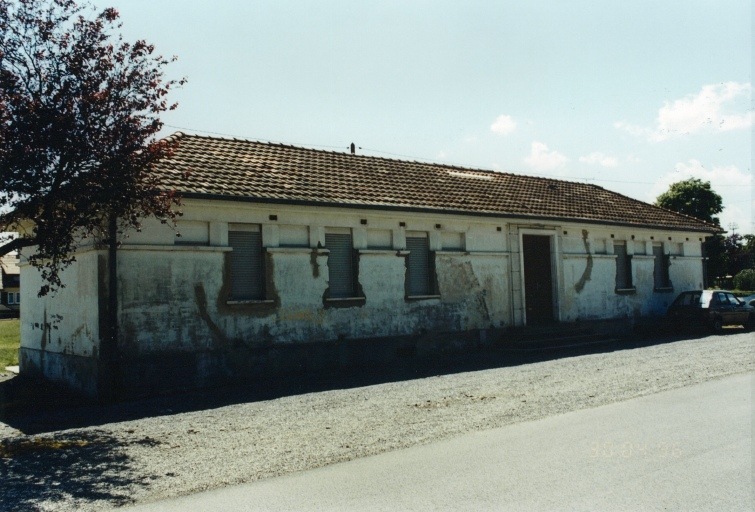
[21,133,718,394]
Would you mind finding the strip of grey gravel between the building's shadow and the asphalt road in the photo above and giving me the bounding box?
[0,333,755,510]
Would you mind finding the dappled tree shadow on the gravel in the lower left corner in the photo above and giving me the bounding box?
[0,430,157,511]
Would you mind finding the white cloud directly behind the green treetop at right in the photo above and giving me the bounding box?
[646,159,753,232]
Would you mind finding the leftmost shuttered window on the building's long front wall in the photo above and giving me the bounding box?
[228,231,265,300]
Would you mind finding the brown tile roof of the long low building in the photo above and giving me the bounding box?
[155,132,720,232]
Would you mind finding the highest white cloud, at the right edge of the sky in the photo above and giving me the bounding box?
[614,82,755,142]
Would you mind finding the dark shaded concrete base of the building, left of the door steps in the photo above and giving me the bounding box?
[20,329,496,400]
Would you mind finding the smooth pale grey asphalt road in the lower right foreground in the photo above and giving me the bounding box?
[129,373,755,511]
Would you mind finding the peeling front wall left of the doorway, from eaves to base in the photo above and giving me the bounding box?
[110,203,511,355]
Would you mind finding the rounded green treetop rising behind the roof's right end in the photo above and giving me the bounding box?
[655,178,723,224]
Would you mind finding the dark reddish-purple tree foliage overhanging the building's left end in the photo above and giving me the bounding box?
[0,0,183,294]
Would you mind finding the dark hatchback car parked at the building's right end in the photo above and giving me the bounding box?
[668,290,755,332]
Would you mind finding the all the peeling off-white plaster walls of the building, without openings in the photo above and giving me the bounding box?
[22,200,716,396]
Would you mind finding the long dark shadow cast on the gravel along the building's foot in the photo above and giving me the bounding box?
[0,329,741,435]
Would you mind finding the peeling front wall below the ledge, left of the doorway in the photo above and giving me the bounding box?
[113,247,510,357]
